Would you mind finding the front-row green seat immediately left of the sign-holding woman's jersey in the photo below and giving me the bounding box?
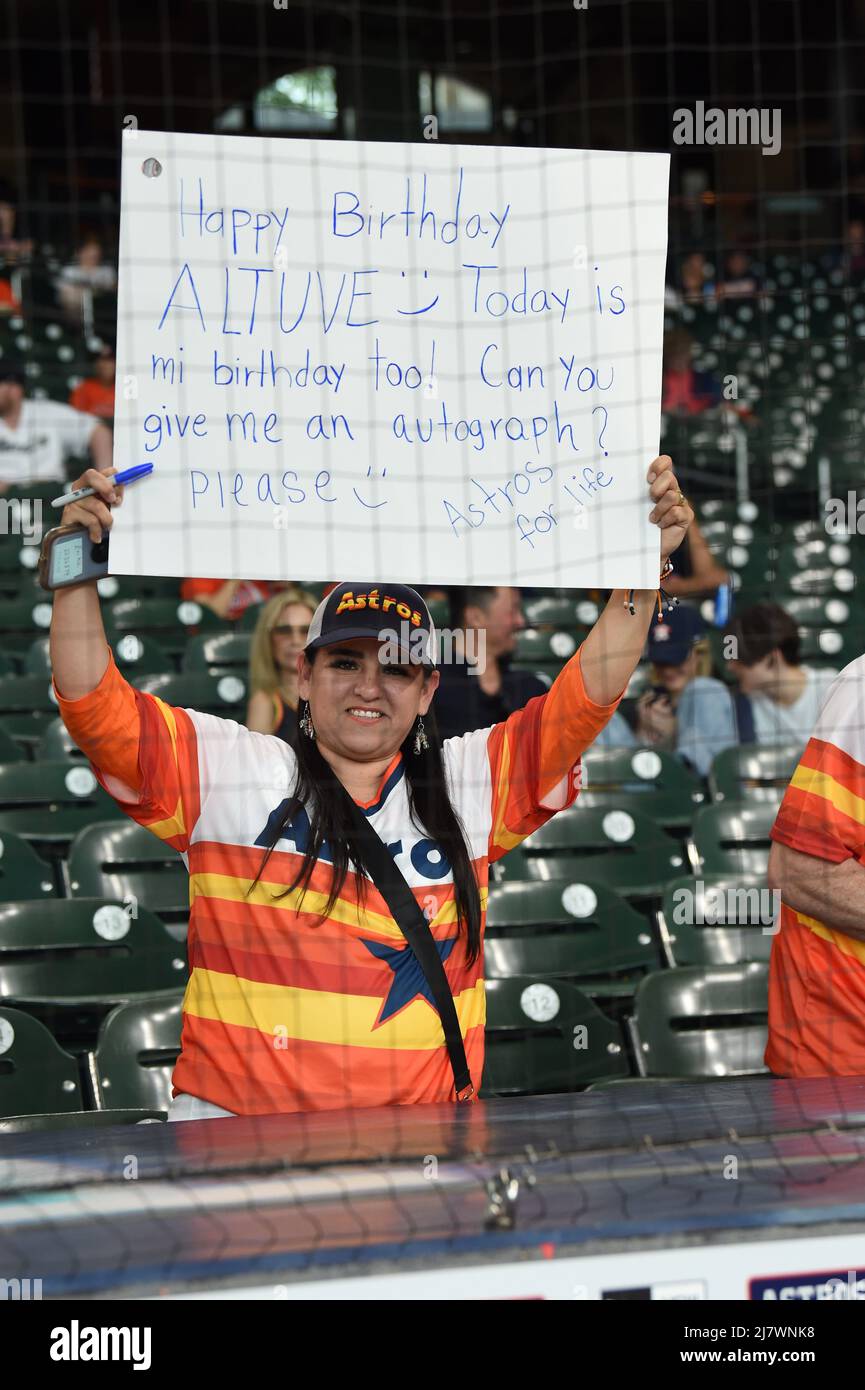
[93,997,182,1111]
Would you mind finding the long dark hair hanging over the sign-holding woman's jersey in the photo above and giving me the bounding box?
[248,652,481,965]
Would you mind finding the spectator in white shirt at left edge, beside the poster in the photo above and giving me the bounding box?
[0,359,113,492]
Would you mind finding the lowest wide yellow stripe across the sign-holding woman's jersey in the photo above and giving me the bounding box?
[184,967,485,1051]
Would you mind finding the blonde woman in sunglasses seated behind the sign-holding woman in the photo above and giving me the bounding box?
[246,588,318,744]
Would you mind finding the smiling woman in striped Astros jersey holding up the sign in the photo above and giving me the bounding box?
[51,457,693,1119]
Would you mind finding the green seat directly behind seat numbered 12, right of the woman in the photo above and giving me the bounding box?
[484,881,659,997]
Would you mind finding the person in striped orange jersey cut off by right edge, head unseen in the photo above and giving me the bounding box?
[766,656,865,1076]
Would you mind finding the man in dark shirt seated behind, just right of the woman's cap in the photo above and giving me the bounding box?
[434,587,547,738]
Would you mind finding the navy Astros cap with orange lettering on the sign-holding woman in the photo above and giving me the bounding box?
[306,580,437,666]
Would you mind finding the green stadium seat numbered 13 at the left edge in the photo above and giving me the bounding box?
[0,898,186,1012]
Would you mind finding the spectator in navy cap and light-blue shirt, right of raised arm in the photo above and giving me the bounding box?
[598,605,736,777]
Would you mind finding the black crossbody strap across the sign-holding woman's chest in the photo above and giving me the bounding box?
[343,788,474,1101]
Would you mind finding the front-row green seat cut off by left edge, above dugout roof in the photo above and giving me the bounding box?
[0,1005,83,1116]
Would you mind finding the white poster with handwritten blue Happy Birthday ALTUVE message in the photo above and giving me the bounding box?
[111,131,669,587]
